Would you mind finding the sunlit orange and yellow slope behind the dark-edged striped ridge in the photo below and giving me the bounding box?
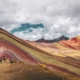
[28,37,80,60]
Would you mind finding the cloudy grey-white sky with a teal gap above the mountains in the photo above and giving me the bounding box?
[0,0,80,40]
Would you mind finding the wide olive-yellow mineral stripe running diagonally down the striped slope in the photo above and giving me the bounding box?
[0,33,80,75]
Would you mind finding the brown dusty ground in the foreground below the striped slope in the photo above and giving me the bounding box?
[0,62,80,80]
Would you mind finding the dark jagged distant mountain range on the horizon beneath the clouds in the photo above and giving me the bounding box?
[36,35,69,43]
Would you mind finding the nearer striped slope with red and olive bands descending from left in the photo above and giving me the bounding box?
[0,29,80,75]
